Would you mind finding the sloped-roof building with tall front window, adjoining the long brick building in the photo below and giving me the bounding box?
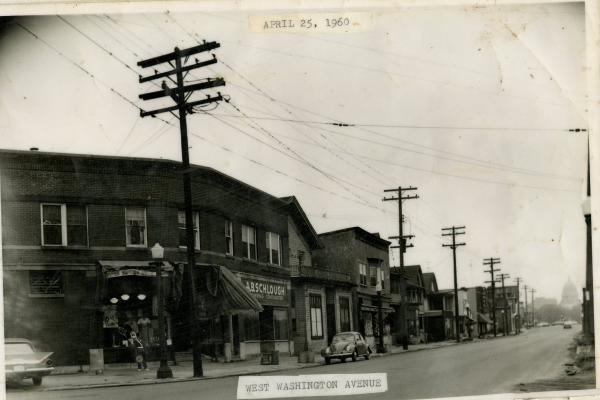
[281,197,357,355]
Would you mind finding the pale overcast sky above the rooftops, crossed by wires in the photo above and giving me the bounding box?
[0,3,587,299]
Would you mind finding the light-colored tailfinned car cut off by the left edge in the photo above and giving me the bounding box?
[4,339,54,386]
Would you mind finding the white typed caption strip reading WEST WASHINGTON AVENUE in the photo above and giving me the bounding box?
[237,373,387,399]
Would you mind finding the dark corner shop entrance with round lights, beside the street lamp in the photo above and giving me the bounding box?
[96,261,183,364]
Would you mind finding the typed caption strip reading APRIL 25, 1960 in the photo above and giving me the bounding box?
[248,12,375,33]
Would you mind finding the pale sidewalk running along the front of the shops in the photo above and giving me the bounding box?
[10,342,474,391]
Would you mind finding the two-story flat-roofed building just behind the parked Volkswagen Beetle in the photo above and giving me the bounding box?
[313,227,395,351]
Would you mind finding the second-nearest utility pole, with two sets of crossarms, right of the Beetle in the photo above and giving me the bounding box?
[380,187,419,350]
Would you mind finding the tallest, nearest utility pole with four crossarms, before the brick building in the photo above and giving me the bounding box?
[137,41,225,377]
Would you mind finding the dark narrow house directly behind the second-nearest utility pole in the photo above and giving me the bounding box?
[390,265,426,344]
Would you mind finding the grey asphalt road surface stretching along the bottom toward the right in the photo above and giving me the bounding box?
[7,325,581,400]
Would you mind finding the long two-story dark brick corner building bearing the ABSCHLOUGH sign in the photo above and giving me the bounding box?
[0,151,293,366]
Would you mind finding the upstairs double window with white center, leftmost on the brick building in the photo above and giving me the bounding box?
[41,204,88,246]
